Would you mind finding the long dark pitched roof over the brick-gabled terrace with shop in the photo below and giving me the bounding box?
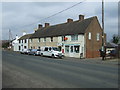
[30,17,95,38]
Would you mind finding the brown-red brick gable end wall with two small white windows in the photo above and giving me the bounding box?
[85,17,102,58]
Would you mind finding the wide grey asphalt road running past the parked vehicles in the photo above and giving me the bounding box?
[2,51,118,88]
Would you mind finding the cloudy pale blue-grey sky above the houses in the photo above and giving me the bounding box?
[0,0,118,41]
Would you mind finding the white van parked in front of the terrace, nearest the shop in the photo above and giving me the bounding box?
[40,47,63,58]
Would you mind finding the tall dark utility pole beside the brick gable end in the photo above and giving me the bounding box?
[102,0,105,60]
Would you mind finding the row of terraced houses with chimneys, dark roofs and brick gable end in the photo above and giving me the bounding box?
[11,15,106,58]
